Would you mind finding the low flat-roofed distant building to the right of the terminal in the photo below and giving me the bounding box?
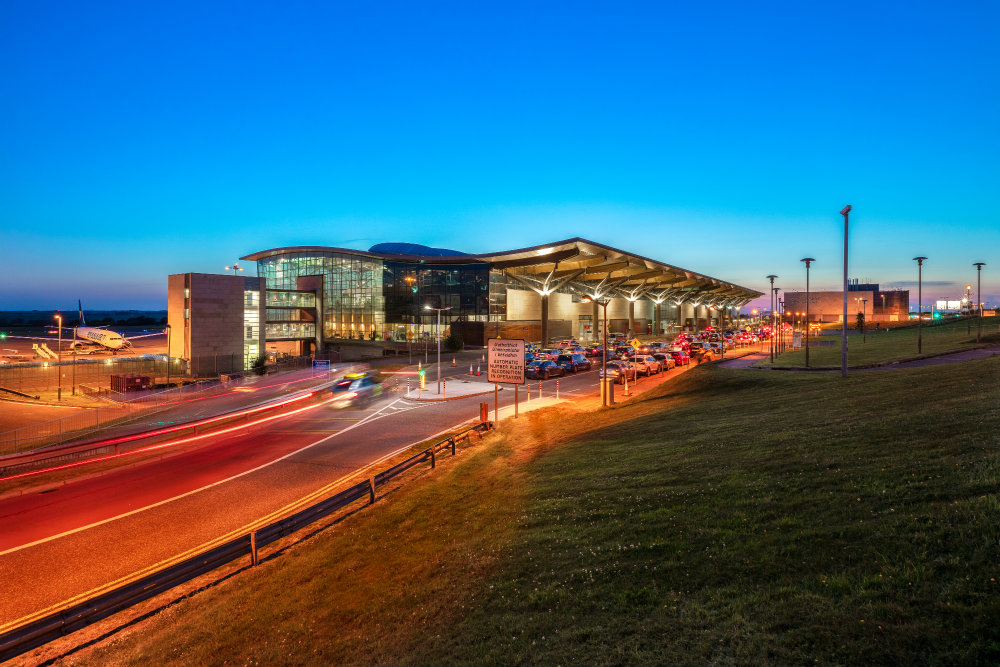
[784,280,910,323]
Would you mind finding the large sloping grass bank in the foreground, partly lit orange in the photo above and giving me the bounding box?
[69,358,1000,665]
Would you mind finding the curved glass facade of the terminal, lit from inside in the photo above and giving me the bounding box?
[257,251,496,341]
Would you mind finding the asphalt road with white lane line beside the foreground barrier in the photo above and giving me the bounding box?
[0,360,648,623]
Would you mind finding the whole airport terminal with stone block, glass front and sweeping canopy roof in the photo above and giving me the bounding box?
[168,238,761,370]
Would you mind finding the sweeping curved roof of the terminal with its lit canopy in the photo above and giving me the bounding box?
[240,238,763,306]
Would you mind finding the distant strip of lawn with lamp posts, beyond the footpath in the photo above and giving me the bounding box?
[757,318,1000,368]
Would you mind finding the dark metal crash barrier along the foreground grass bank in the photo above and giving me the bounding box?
[0,422,493,662]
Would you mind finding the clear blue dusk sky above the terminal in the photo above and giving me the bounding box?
[0,1,1000,309]
